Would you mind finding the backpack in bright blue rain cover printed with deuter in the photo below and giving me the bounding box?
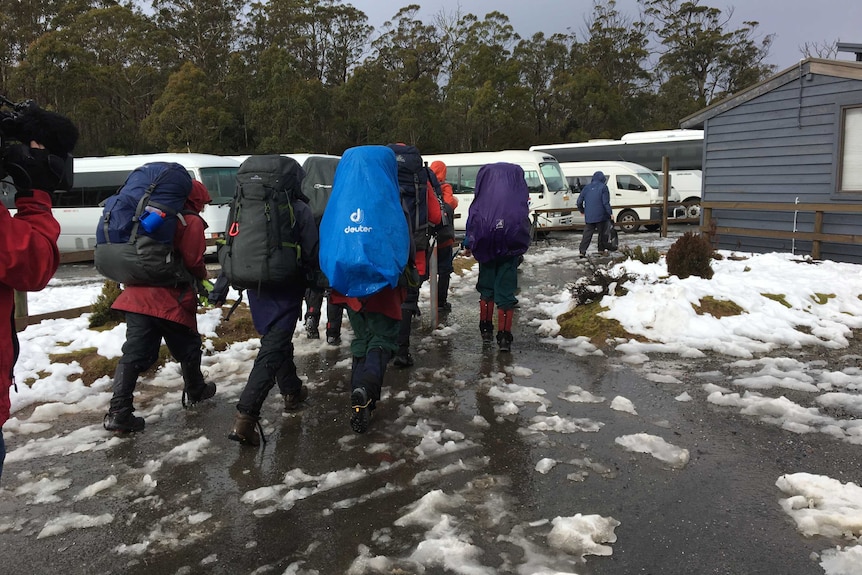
[320,146,410,298]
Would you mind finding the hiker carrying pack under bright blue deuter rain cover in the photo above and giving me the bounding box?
[320,146,424,433]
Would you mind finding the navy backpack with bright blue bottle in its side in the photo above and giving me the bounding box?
[93,162,194,286]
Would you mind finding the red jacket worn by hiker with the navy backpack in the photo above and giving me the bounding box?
[111,180,210,331]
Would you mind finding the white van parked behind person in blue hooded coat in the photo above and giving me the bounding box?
[560,161,685,233]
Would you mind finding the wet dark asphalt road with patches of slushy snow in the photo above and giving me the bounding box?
[0,234,862,575]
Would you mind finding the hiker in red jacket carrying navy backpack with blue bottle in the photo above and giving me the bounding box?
[102,177,216,433]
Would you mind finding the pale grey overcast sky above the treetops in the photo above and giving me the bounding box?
[345,0,862,71]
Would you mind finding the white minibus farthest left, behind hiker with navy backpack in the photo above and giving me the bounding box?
[44,154,239,253]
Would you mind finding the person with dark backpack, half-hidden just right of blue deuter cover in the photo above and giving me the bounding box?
[388,143,442,367]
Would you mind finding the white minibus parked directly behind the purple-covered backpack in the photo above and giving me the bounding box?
[422,150,583,235]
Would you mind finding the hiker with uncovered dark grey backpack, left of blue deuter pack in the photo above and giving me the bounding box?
[218,154,320,446]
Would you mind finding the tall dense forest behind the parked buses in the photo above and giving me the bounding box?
[0,0,818,157]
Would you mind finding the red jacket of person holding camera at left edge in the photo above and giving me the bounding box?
[0,190,60,427]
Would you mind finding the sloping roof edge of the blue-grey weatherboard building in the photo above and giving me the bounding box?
[679,58,862,128]
